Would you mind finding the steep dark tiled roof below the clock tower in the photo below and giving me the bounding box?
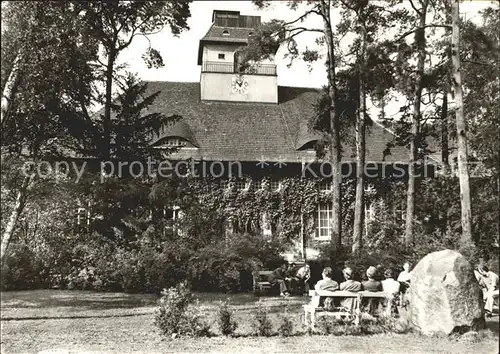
[143,82,408,162]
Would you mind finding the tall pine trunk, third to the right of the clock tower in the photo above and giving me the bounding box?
[405,0,428,247]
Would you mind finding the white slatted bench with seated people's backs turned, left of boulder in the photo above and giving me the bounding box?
[303,290,391,330]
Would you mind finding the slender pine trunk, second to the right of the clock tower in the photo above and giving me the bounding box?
[352,19,366,253]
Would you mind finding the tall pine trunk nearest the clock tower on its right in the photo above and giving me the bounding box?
[323,4,342,249]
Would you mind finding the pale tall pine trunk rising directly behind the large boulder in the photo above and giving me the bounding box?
[451,0,472,244]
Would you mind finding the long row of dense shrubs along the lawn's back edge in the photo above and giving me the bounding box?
[1,231,281,293]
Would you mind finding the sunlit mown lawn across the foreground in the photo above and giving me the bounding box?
[1,290,499,353]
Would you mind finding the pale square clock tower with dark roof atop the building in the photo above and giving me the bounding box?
[198,10,278,104]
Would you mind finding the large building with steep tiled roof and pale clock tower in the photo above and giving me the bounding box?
[142,10,418,260]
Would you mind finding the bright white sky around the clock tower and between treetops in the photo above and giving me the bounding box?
[120,0,494,87]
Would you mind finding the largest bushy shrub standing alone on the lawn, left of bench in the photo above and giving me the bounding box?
[154,283,210,338]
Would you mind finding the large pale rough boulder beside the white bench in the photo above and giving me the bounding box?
[409,250,484,335]
